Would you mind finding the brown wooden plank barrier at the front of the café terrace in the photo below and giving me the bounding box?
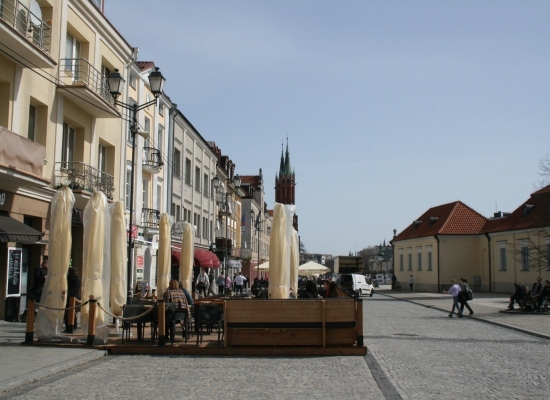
[224,298,363,347]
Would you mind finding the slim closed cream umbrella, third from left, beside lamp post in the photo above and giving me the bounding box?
[110,201,128,315]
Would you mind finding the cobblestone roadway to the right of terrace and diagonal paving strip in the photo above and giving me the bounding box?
[364,296,550,399]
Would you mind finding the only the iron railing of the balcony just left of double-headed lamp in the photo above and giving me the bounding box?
[59,58,114,105]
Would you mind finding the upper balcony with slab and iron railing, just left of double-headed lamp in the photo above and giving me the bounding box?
[57,58,121,118]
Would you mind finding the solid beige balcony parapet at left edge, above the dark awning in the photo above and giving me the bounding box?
[0,126,50,192]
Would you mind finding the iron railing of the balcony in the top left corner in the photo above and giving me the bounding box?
[0,0,51,55]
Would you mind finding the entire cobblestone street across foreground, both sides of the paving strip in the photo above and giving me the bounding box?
[0,295,550,400]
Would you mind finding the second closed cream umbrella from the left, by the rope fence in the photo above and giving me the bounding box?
[81,191,111,340]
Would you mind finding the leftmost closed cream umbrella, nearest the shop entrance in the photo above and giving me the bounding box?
[35,186,75,340]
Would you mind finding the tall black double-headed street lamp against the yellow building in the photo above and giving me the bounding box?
[107,68,166,304]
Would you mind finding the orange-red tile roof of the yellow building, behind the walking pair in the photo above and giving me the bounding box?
[393,201,487,242]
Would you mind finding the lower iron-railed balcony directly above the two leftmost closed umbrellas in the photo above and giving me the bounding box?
[52,161,115,200]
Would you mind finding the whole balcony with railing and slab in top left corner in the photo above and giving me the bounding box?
[0,0,56,68]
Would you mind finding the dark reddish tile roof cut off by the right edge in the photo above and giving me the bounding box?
[483,185,550,233]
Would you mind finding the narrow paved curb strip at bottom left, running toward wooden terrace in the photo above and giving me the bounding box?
[0,350,107,395]
